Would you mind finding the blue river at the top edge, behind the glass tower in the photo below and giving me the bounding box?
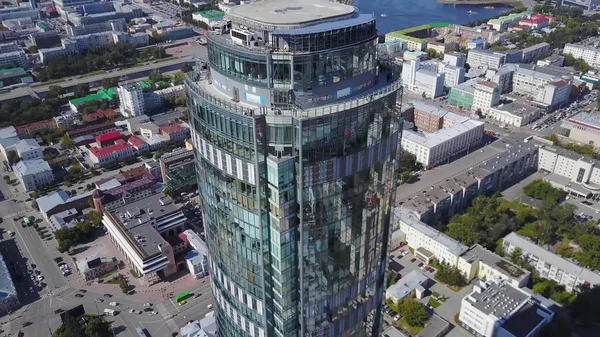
[354,0,511,34]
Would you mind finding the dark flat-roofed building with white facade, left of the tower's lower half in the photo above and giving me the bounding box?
[99,193,186,284]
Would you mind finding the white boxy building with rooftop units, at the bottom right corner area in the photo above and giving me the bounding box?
[458,279,554,337]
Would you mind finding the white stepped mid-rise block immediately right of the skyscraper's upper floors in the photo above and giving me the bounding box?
[402,60,445,98]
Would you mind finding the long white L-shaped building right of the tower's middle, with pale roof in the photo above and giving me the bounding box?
[402,115,484,168]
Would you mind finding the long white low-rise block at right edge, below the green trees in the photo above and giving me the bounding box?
[502,232,600,291]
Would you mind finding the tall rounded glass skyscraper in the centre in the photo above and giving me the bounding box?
[185,0,402,337]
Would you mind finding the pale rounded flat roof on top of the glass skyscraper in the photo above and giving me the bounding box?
[229,0,355,25]
